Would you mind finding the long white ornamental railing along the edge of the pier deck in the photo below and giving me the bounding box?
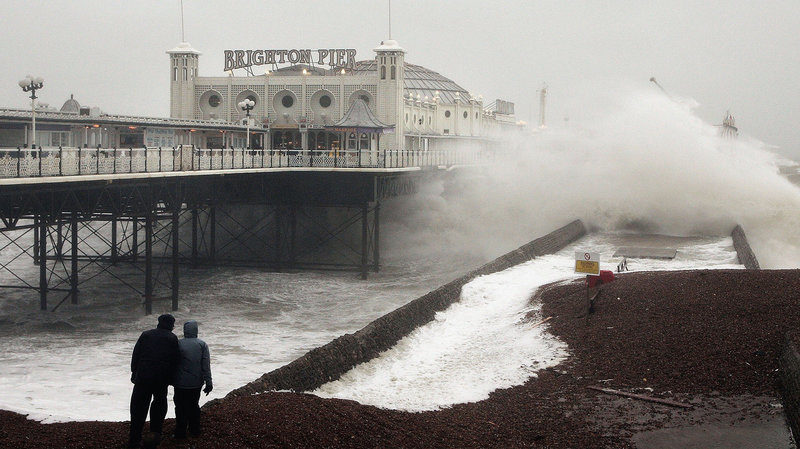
[0,145,492,178]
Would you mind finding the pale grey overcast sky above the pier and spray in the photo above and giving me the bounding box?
[0,0,800,158]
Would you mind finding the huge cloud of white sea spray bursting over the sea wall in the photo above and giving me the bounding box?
[384,88,800,268]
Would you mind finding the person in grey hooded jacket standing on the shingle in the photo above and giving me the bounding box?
[173,321,214,438]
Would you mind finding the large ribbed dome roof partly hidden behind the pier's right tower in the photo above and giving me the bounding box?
[355,59,470,103]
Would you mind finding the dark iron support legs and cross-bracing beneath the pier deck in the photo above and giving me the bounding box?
[0,170,391,314]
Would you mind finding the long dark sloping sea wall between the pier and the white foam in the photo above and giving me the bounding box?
[225,220,586,396]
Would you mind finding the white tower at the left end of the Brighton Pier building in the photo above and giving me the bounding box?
[167,42,200,118]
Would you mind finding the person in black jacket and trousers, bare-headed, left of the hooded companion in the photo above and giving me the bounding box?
[128,314,180,447]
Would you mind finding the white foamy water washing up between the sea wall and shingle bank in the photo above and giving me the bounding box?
[314,231,742,411]
